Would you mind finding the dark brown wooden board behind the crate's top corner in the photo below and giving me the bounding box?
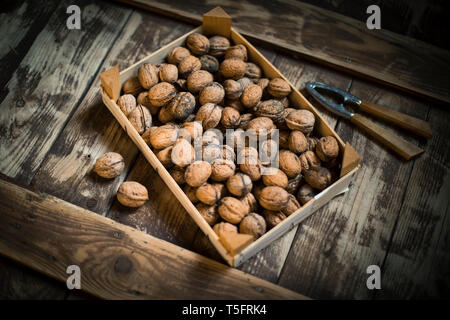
[121,0,450,104]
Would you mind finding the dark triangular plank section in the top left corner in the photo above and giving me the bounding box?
[0,1,58,95]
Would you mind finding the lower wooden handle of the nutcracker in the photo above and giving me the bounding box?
[351,114,423,160]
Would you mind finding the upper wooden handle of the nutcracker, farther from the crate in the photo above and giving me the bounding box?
[360,100,432,139]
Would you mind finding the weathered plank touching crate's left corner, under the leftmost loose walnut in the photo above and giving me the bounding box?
[32,12,192,215]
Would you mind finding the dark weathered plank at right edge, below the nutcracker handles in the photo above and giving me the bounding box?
[375,108,450,299]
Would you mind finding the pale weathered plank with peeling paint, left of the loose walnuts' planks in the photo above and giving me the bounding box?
[0,1,131,183]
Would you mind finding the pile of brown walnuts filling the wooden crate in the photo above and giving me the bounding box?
[114,33,339,238]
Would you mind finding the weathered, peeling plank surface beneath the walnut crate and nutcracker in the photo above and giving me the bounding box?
[0,1,450,299]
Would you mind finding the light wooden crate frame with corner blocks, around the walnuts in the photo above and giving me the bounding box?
[100,7,359,267]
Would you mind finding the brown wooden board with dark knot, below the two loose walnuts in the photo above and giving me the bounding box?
[0,180,305,299]
